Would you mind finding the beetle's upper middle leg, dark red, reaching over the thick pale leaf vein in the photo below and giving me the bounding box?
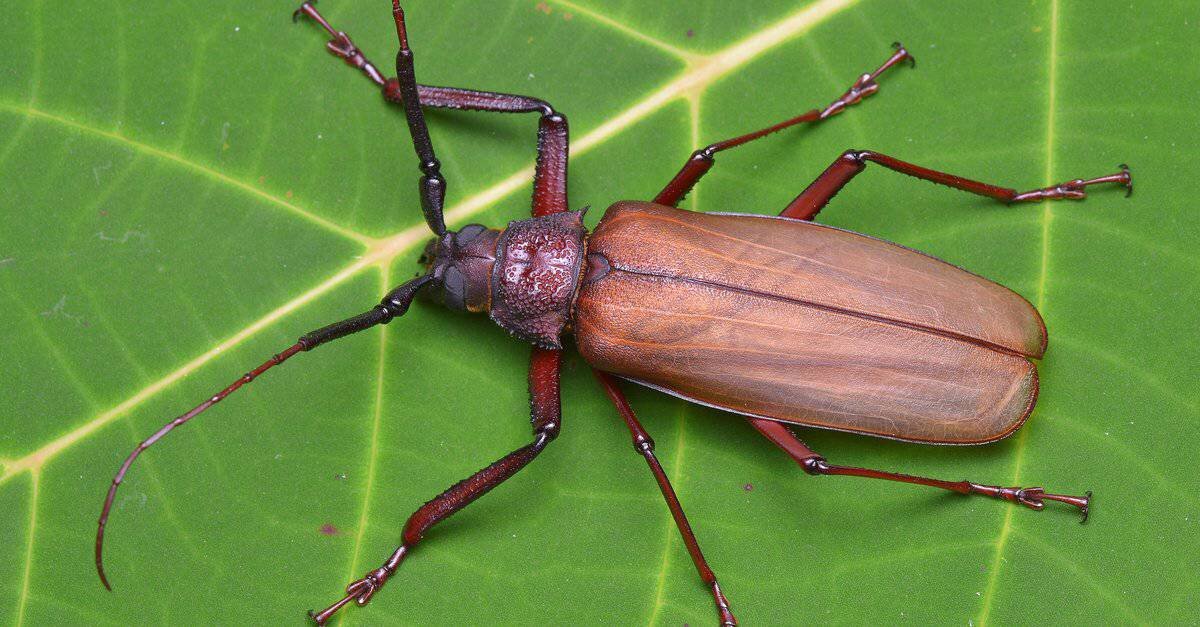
[654,42,916,207]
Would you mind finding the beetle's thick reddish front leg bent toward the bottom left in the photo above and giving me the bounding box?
[308,348,562,625]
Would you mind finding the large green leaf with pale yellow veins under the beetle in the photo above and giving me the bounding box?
[0,0,1200,625]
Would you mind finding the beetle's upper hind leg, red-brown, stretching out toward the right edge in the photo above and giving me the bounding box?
[779,150,1133,220]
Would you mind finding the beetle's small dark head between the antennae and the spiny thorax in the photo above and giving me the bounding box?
[421,225,500,312]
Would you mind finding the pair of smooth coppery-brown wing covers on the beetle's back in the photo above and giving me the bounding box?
[574,202,1046,444]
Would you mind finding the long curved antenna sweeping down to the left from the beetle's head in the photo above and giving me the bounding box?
[96,276,431,590]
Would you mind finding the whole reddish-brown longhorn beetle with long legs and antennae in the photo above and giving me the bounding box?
[95,0,1133,626]
